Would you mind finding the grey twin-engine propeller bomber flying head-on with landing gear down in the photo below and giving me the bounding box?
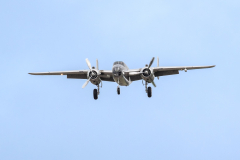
[29,57,215,100]
